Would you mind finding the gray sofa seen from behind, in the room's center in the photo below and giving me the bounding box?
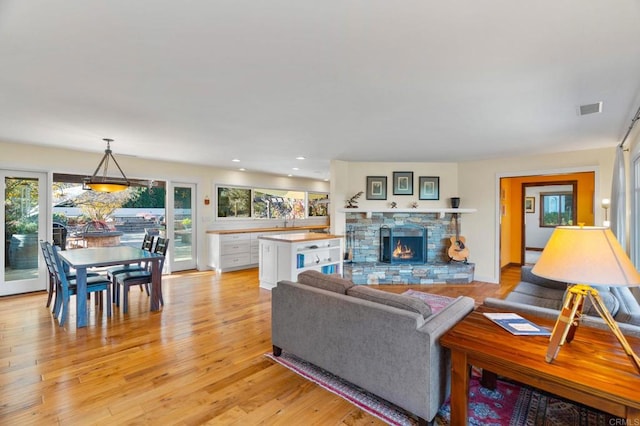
[271,271,474,424]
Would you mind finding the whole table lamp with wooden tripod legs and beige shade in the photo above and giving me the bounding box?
[531,226,640,373]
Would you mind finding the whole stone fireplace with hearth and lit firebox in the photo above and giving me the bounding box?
[344,210,474,284]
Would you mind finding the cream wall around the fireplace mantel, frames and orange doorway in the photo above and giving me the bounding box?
[331,147,615,283]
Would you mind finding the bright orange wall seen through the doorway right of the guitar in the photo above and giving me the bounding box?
[500,172,595,267]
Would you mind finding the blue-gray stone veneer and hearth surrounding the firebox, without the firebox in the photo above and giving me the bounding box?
[344,212,475,284]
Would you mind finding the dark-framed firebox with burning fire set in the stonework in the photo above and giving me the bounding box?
[380,225,427,263]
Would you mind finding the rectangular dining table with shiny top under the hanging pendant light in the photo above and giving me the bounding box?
[58,245,164,327]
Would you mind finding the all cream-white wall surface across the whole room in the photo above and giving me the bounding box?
[0,142,615,282]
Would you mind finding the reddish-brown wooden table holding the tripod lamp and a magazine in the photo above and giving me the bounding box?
[440,306,640,426]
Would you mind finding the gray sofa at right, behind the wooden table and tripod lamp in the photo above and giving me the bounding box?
[484,265,640,337]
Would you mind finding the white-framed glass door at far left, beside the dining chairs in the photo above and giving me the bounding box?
[0,170,47,296]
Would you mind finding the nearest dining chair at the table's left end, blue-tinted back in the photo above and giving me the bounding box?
[45,242,111,327]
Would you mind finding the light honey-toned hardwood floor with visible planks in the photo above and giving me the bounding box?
[0,268,519,425]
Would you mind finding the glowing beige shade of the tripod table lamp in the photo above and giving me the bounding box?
[531,226,640,286]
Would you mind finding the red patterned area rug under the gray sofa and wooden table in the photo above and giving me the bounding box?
[265,352,624,426]
